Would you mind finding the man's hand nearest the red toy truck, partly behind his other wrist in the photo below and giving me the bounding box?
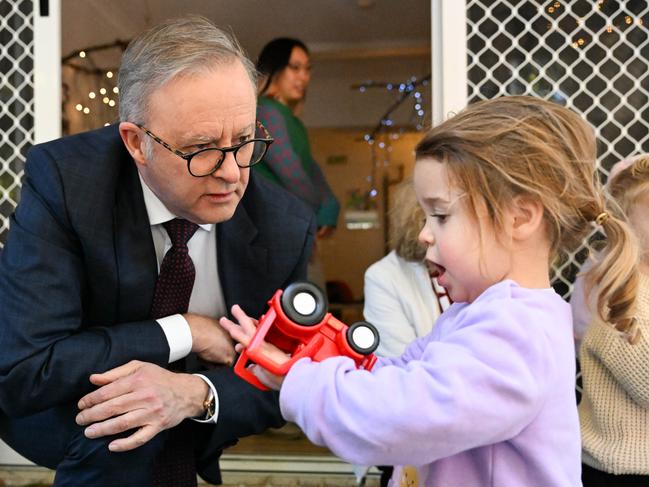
[183,313,235,365]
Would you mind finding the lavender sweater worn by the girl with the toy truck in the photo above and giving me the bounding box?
[280,281,581,487]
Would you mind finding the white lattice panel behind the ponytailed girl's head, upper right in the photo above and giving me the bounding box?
[467,0,649,297]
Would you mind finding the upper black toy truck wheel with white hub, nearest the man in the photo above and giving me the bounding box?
[280,282,327,326]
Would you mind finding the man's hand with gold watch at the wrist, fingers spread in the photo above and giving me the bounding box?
[76,360,208,452]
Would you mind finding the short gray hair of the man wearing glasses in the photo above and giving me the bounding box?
[118,15,257,123]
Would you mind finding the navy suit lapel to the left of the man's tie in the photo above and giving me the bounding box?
[113,157,158,323]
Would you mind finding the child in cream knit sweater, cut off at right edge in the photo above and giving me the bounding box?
[579,154,649,487]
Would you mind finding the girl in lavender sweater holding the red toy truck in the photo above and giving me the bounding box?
[221,97,636,487]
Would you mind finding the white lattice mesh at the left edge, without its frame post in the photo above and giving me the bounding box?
[0,0,34,248]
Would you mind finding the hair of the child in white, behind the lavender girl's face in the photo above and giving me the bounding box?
[390,178,426,262]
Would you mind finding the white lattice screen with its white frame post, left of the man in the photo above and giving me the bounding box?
[0,0,61,249]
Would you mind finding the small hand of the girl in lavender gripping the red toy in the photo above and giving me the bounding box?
[219,304,290,391]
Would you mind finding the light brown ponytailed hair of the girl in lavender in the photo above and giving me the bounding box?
[415,96,638,340]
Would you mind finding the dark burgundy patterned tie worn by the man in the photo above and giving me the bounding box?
[151,218,198,487]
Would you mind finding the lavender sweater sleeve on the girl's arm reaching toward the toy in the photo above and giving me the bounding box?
[280,305,555,465]
